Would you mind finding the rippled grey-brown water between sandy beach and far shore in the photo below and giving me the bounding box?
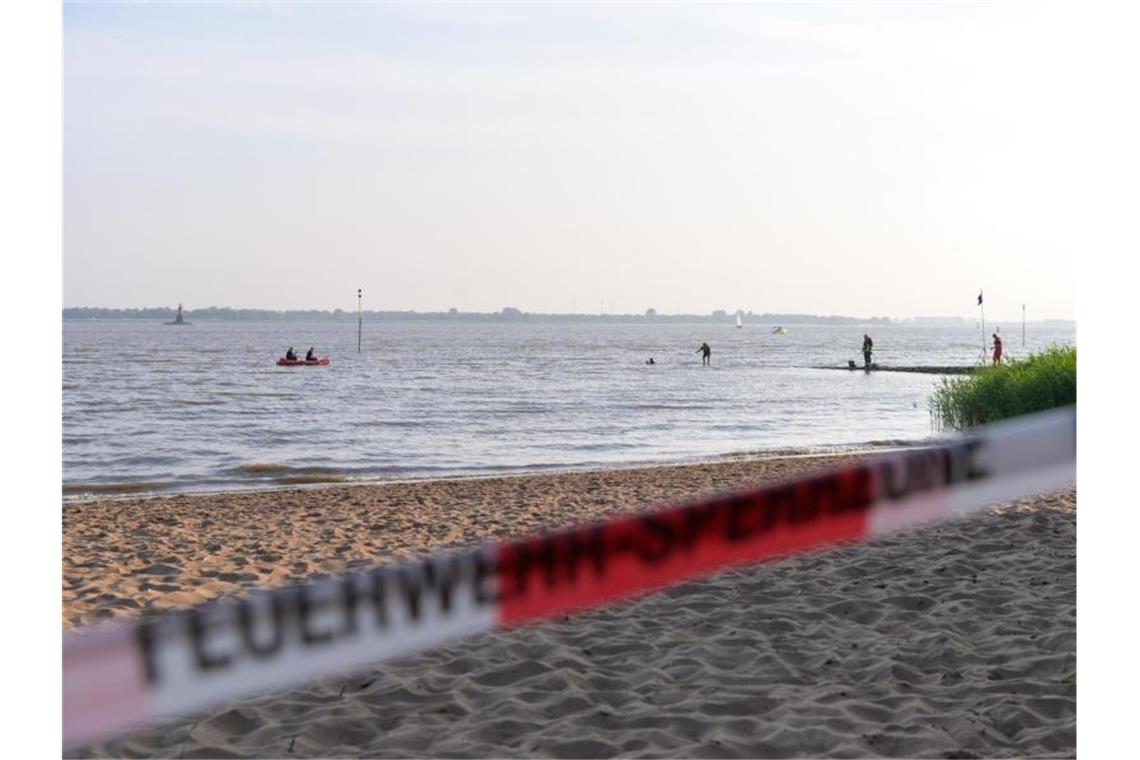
[63,320,1075,497]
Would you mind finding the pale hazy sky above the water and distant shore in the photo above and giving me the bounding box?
[64,2,1081,318]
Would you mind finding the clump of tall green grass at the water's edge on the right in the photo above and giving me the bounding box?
[930,345,1076,430]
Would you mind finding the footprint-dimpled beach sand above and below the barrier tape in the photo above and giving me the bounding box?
[64,458,1076,758]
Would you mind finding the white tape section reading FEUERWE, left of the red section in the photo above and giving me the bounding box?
[149,555,496,718]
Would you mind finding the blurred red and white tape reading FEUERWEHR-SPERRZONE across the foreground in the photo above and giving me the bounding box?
[63,408,1076,746]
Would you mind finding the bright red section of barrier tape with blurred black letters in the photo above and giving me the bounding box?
[498,466,876,626]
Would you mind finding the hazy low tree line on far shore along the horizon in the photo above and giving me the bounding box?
[64,307,891,325]
